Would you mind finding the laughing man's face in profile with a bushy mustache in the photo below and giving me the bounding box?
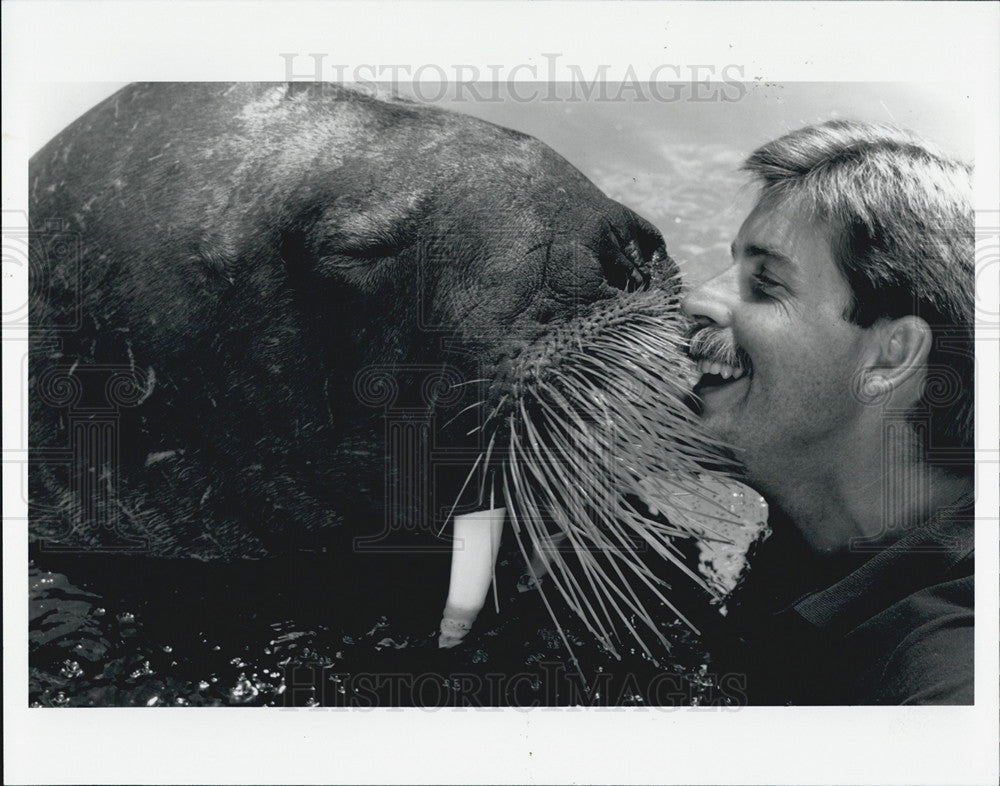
[684,194,869,494]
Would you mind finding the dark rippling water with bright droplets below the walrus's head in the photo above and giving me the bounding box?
[29,550,739,707]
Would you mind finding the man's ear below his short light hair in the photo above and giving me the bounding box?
[867,316,932,402]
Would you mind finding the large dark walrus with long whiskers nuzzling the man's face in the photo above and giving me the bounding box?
[29,83,744,664]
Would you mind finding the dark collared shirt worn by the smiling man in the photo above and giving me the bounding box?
[717,509,974,704]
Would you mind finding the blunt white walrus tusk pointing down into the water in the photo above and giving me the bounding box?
[438,508,507,649]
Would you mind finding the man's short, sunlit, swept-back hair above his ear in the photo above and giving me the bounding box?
[743,120,975,469]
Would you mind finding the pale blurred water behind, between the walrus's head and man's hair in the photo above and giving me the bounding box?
[438,81,975,284]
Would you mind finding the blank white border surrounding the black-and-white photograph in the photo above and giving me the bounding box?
[3,1,1000,784]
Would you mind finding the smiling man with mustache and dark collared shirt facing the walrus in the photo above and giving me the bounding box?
[685,121,974,704]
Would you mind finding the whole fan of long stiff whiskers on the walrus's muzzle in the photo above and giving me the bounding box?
[472,291,748,657]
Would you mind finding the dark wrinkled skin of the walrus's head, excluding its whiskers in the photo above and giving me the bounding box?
[29,83,674,558]
